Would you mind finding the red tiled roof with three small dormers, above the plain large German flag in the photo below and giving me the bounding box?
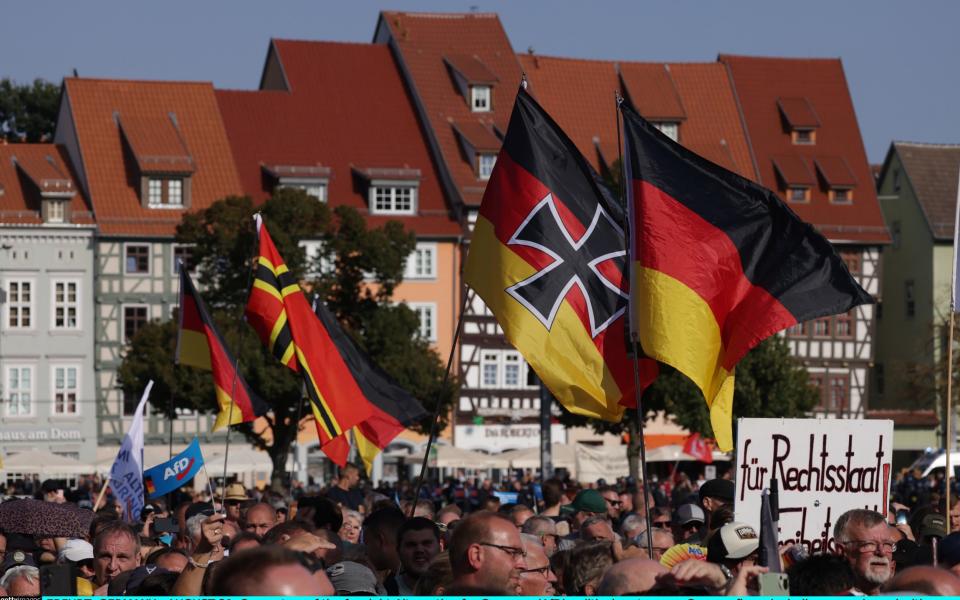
[719,55,890,244]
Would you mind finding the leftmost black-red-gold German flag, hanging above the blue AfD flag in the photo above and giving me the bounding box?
[176,265,270,431]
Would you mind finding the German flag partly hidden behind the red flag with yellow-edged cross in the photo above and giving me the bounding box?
[314,298,427,474]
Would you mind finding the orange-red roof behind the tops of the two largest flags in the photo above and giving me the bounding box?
[518,54,756,179]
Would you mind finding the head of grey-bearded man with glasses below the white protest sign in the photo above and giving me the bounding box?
[833,508,899,595]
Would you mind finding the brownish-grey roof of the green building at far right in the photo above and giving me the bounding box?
[884,142,960,241]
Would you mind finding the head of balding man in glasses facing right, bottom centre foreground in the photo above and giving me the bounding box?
[447,511,527,596]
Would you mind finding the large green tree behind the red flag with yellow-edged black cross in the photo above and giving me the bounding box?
[120,189,457,488]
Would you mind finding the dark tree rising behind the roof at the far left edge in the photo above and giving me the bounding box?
[0,78,60,143]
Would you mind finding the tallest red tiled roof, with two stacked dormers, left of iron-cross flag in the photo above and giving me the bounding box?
[380,12,521,206]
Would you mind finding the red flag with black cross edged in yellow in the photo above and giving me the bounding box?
[247,216,373,466]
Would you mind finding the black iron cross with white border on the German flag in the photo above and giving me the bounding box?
[506,194,628,338]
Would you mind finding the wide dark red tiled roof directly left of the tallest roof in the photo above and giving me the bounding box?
[216,40,460,236]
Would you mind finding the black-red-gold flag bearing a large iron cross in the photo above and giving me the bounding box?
[464,88,657,421]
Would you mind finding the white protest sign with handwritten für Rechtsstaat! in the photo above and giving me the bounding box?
[734,419,893,553]
